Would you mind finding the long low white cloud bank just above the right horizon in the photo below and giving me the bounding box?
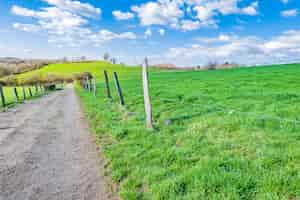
[166,30,300,65]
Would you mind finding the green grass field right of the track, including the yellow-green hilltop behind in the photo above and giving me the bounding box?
[7,63,300,200]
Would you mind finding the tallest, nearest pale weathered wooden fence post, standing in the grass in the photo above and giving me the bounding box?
[142,58,153,129]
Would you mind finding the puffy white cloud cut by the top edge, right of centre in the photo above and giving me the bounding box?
[131,0,259,31]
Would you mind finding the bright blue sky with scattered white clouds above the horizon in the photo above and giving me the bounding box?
[0,0,300,66]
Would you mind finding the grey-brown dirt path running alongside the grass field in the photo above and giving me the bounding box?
[0,88,115,200]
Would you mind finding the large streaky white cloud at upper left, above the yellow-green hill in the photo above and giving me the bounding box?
[11,0,137,46]
